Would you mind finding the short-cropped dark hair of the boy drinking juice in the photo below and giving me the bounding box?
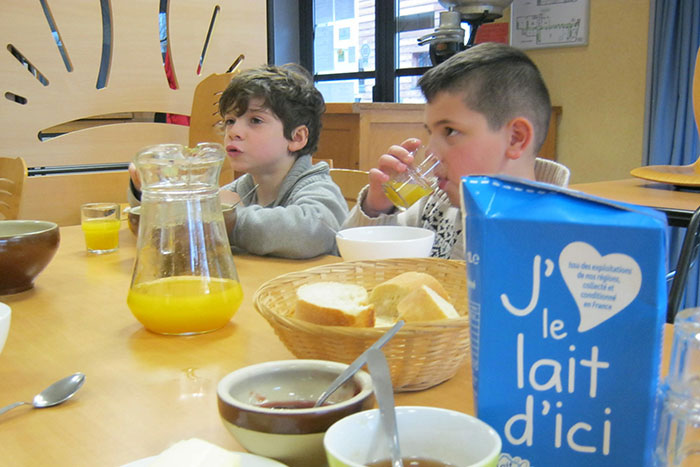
[418,42,552,155]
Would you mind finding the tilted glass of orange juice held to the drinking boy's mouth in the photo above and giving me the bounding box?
[384,146,440,211]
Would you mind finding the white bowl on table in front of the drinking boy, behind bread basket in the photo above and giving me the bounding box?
[335,225,435,261]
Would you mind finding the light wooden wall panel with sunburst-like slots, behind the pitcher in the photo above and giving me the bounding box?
[0,0,267,227]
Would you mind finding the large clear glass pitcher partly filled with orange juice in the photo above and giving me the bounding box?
[127,143,243,335]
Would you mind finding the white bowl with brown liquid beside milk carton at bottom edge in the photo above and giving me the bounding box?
[323,406,501,467]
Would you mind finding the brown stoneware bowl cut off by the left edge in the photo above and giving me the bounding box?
[0,220,60,295]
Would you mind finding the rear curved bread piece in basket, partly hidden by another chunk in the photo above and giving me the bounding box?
[369,271,450,325]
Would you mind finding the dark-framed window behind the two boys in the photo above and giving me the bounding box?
[299,0,456,102]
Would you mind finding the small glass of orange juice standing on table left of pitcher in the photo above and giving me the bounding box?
[80,203,121,255]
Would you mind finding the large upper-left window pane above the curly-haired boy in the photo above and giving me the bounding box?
[314,0,375,74]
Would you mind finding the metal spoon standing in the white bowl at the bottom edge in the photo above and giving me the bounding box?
[367,349,403,467]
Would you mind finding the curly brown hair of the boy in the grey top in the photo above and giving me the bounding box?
[219,64,326,157]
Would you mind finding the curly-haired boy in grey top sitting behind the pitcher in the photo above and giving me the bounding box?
[129,64,348,258]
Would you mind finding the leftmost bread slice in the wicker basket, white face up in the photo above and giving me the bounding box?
[294,282,374,327]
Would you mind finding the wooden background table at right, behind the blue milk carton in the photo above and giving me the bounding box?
[571,178,700,227]
